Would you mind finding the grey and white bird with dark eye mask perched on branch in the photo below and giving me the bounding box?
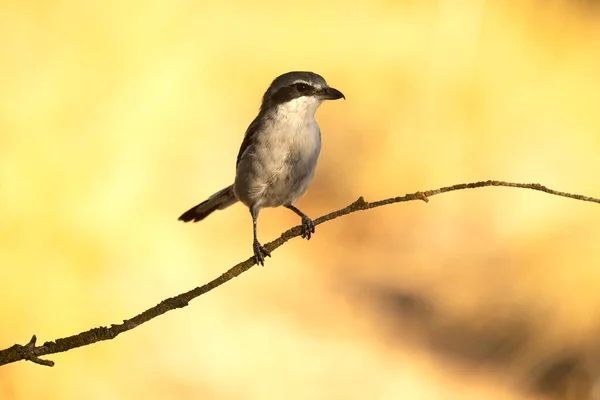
[179,71,346,266]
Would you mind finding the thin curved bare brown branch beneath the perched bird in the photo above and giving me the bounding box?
[0,181,600,367]
